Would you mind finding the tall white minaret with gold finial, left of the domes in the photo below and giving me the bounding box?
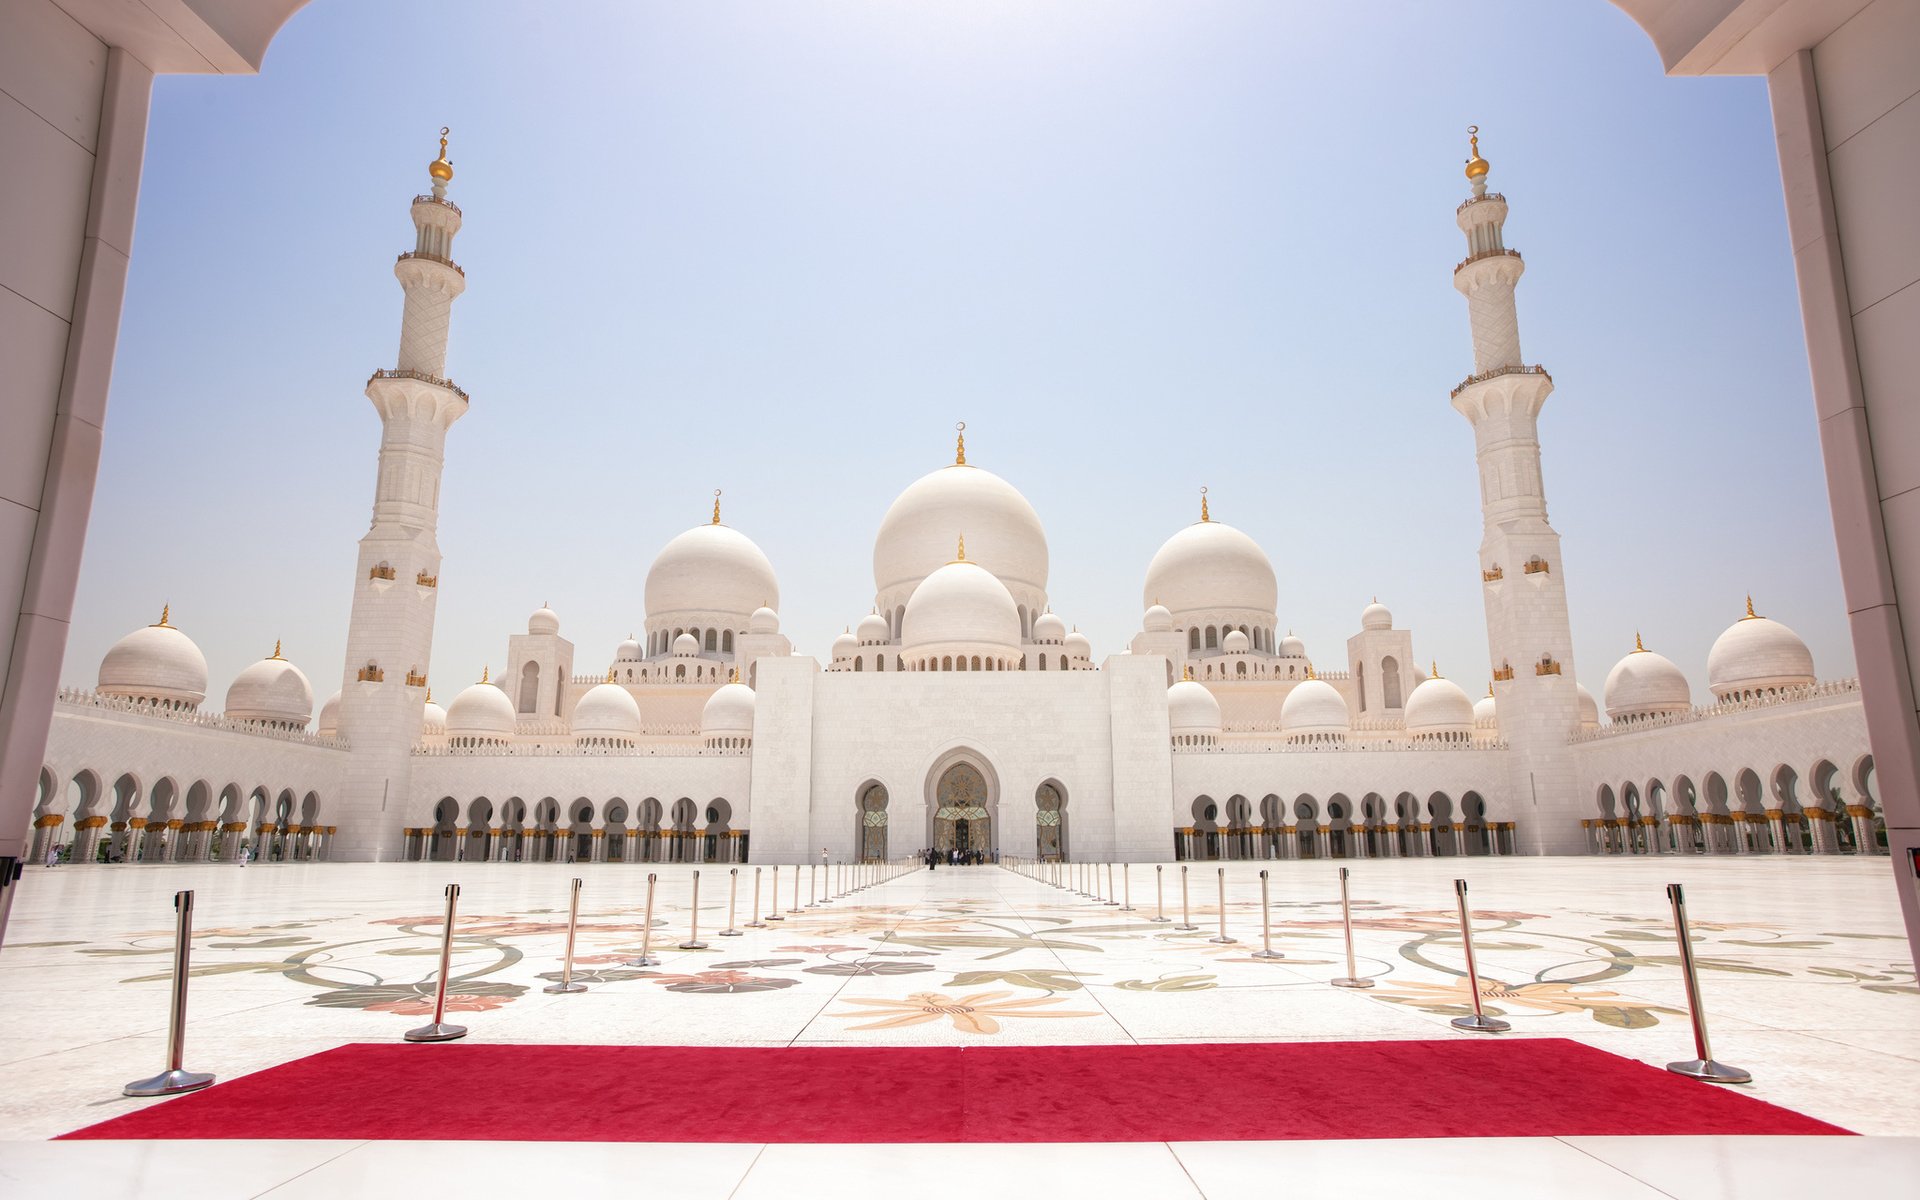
[328,129,467,860]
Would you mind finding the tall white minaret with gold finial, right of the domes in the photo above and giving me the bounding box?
[1453,127,1584,854]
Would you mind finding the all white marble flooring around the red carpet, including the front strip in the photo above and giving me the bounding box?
[0,858,1920,1200]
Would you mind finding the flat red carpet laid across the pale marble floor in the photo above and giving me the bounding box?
[65,1039,1847,1142]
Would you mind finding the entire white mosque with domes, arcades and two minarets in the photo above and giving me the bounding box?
[22,136,1885,862]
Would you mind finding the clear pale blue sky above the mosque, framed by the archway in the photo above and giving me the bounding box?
[65,0,1853,707]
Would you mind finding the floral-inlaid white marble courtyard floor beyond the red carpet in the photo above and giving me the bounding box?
[0,858,1920,1139]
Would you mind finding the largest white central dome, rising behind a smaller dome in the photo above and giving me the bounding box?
[874,465,1046,609]
